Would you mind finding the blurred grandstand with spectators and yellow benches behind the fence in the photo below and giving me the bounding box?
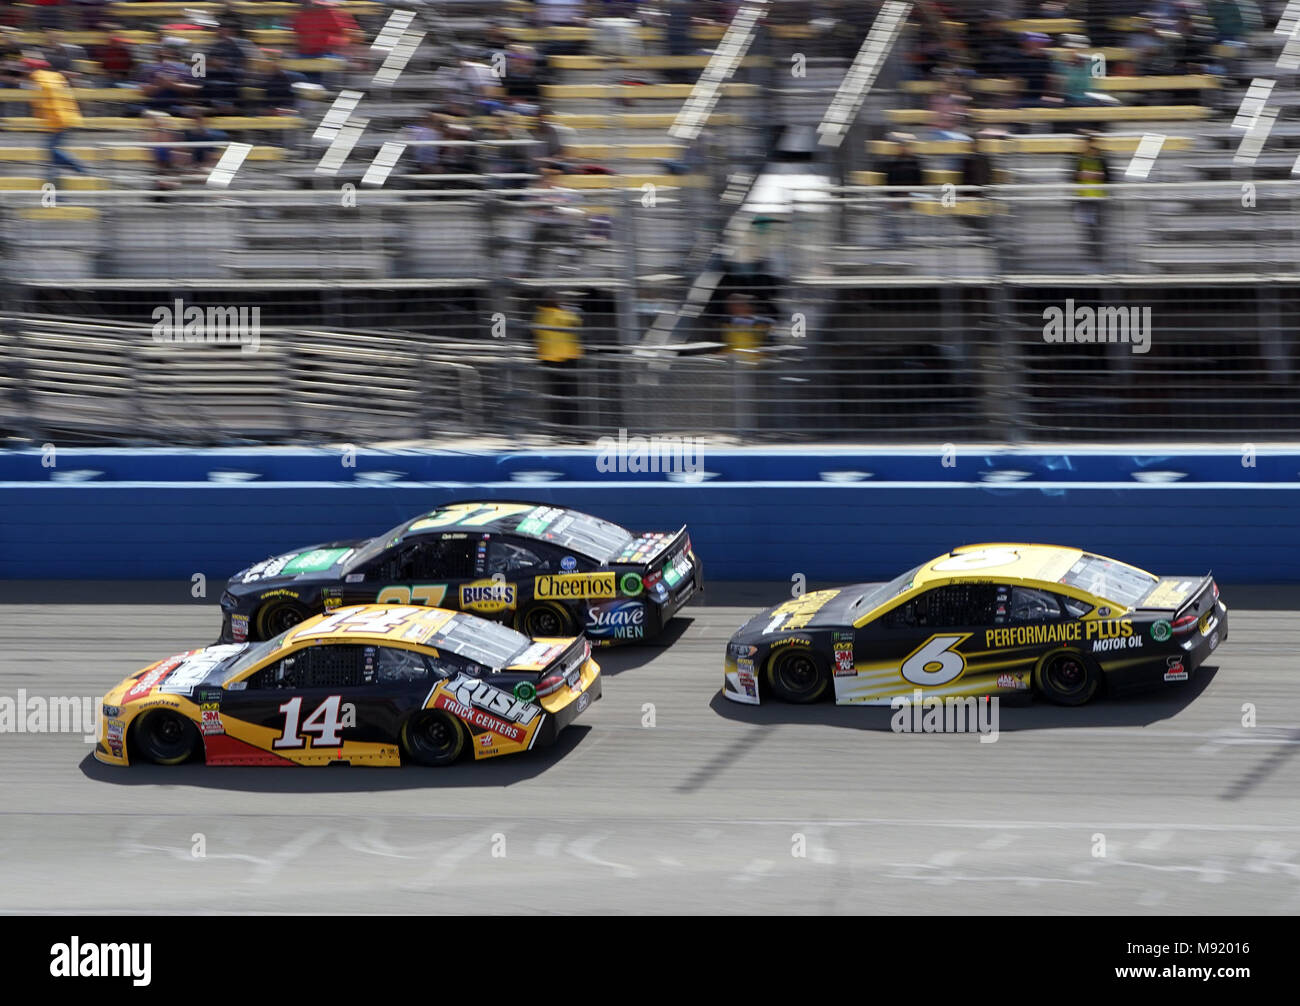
[0,0,1300,442]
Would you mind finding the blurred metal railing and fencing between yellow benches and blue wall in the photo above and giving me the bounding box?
[0,178,1300,443]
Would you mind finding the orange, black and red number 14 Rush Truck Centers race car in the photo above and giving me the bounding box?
[95,604,601,766]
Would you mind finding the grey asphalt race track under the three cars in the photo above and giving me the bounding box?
[0,584,1300,920]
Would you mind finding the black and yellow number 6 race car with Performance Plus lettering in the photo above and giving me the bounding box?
[723,543,1227,706]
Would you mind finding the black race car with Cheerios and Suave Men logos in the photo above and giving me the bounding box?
[220,502,703,646]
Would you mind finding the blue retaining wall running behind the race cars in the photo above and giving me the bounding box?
[0,446,1300,582]
